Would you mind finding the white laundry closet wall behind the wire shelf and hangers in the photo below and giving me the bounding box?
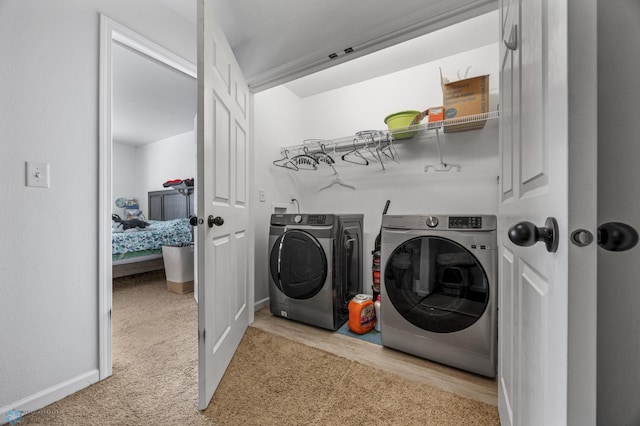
[255,44,499,300]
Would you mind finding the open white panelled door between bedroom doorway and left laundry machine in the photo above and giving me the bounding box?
[196,0,253,409]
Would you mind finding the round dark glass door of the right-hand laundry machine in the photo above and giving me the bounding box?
[384,237,489,333]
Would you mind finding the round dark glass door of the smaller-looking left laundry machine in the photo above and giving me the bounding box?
[270,229,327,299]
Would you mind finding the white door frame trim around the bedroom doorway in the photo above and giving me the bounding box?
[98,14,197,380]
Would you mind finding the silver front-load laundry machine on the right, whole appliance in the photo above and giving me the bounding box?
[380,215,498,377]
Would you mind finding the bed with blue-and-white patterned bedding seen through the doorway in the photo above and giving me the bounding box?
[111,218,193,278]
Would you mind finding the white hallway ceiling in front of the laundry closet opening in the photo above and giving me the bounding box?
[160,0,498,91]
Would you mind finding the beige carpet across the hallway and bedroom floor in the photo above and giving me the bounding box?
[19,273,499,425]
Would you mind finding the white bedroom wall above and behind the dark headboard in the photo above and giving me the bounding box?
[135,131,196,217]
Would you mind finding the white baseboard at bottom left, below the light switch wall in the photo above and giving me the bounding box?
[0,369,100,425]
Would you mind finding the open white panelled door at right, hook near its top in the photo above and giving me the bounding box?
[498,0,598,425]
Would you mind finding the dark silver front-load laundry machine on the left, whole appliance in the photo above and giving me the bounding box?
[269,214,364,330]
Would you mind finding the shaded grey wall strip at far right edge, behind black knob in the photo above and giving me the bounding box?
[597,0,640,425]
